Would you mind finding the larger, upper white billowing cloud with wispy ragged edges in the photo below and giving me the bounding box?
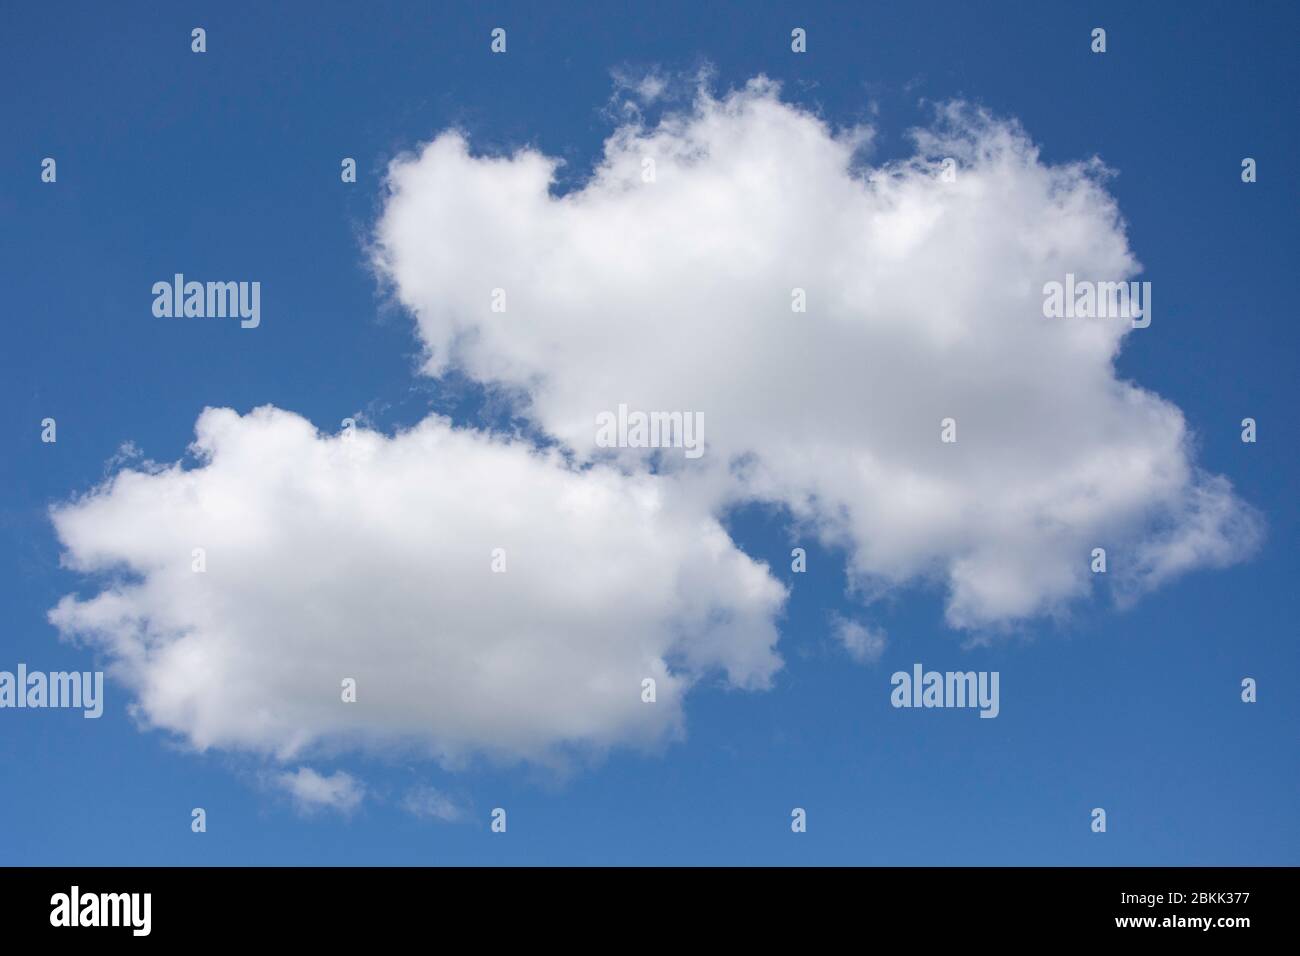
[374,79,1260,628]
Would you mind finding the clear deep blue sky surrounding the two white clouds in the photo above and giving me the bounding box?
[0,3,1300,865]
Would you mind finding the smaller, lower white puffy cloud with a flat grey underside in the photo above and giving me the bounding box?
[51,407,785,763]
